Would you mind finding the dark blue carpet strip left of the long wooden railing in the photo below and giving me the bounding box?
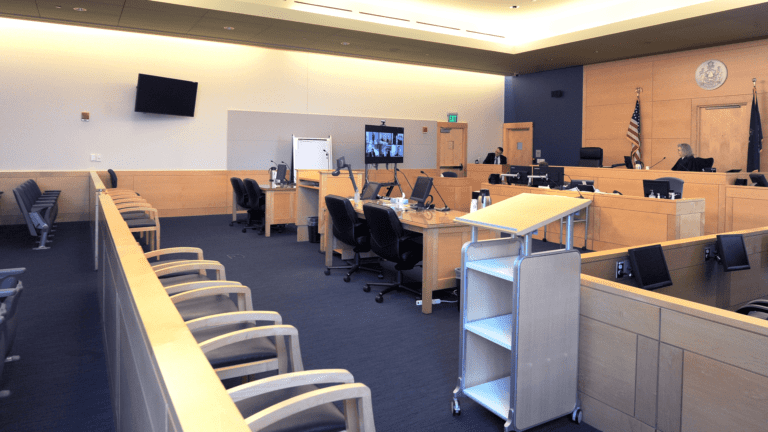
[0,222,115,432]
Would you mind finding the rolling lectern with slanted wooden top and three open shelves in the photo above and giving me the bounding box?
[451,194,592,432]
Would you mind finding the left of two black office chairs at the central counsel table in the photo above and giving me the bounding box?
[325,195,384,282]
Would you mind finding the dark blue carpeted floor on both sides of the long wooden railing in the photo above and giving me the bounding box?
[0,215,594,432]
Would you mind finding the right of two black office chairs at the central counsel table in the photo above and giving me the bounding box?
[363,204,423,303]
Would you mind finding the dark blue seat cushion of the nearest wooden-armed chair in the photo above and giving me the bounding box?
[235,385,346,432]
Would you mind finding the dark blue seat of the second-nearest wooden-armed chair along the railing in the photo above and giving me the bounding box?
[192,323,277,368]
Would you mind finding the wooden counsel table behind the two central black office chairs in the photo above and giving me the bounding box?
[323,201,498,314]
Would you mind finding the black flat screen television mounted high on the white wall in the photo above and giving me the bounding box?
[134,74,197,117]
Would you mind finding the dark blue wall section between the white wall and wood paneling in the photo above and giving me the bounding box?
[504,66,584,166]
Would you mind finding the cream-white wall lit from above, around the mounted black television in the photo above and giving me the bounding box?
[0,18,504,170]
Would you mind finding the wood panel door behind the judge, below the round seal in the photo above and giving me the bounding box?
[693,103,751,172]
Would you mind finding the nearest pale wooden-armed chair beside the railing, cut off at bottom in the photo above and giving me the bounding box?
[228,369,376,432]
